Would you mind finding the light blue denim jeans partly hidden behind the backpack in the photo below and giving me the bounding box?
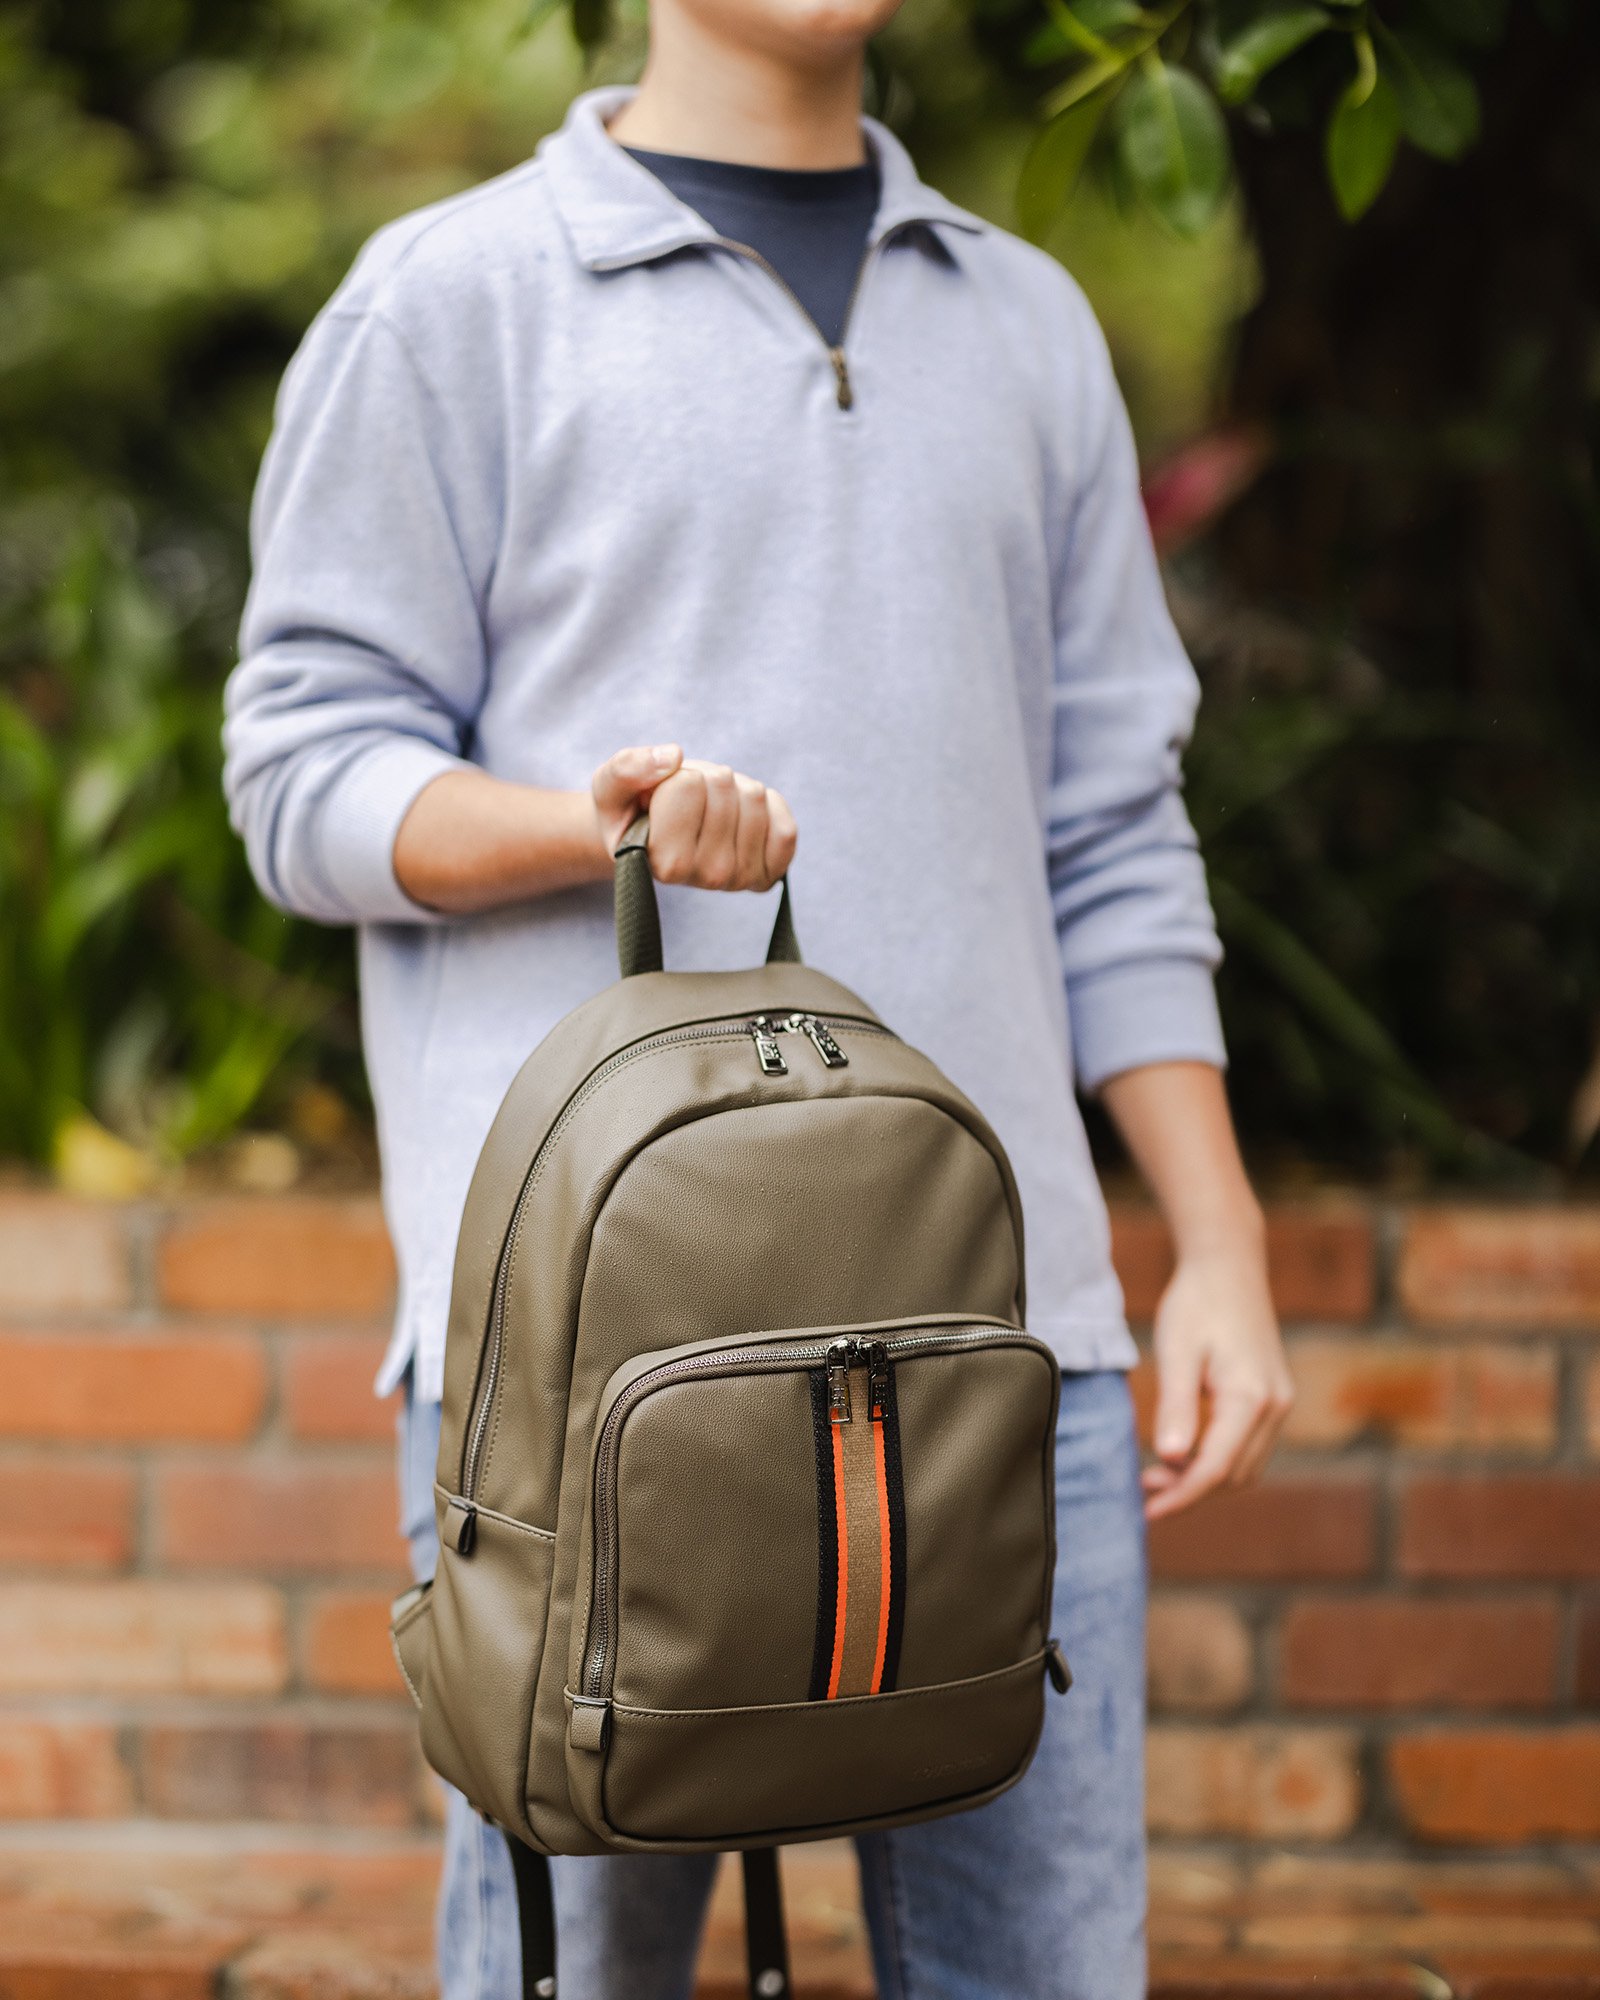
[400,1372,1144,2000]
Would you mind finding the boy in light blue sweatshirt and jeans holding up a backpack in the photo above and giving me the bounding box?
[228,0,1290,2000]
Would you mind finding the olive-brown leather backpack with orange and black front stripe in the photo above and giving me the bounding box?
[394,820,1070,1996]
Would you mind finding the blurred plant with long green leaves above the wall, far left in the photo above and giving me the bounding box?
[0,518,354,1168]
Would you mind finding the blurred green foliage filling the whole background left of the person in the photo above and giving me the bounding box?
[0,0,580,1160]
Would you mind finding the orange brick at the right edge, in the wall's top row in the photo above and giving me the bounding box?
[1400,1206,1600,1326]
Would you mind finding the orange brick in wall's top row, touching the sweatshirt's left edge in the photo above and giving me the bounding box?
[156,1198,394,1320]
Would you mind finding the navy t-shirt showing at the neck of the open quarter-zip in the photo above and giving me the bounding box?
[626,146,878,348]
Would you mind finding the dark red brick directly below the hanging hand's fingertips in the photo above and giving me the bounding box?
[1150,1478,1378,1580]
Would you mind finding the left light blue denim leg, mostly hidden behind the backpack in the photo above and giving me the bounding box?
[400,1378,716,2000]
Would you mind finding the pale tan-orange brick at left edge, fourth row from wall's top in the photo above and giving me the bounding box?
[0,1578,288,1694]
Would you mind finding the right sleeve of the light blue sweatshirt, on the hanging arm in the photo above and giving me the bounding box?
[1046,294,1226,1090]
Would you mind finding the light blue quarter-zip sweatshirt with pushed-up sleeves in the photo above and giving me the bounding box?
[226,90,1222,1398]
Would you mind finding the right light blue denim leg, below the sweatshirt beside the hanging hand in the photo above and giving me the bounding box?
[856,1370,1146,2000]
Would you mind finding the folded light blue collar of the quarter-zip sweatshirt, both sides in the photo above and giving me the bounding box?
[538,88,984,270]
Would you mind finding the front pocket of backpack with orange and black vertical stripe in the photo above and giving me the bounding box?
[568,1318,1060,1844]
